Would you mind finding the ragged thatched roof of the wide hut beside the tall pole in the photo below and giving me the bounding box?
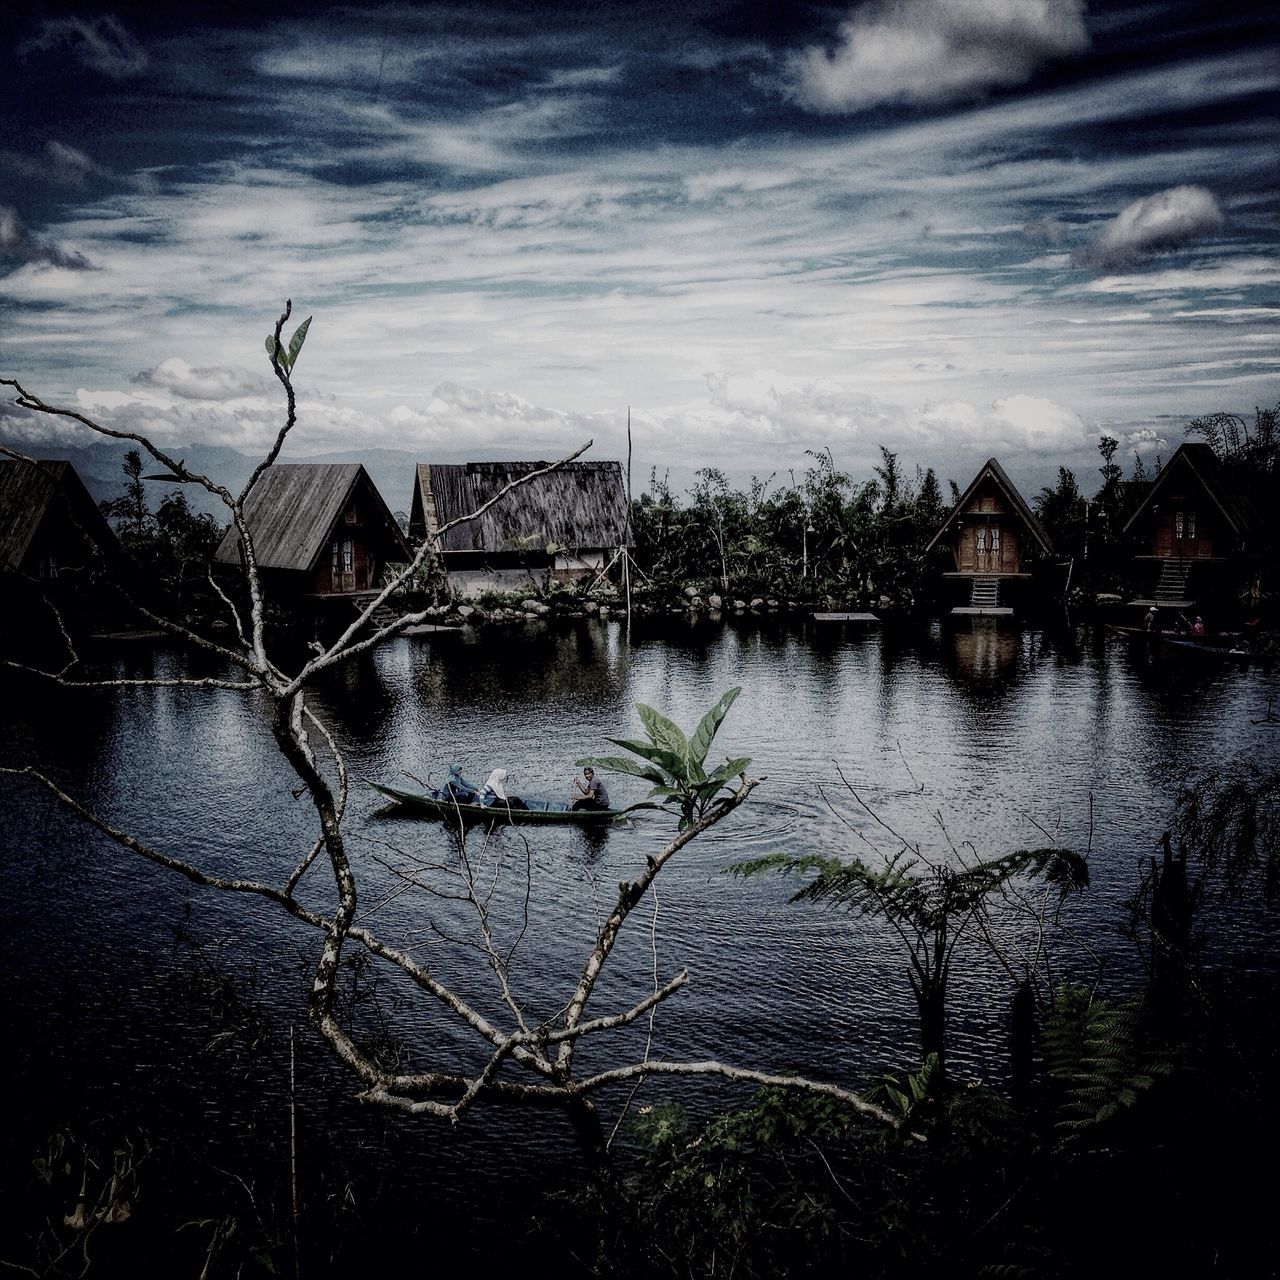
[410,462,628,552]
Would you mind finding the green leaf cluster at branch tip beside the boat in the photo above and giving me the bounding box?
[577,687,751,831]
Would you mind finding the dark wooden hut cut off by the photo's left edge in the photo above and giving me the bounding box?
[0,460,119,582]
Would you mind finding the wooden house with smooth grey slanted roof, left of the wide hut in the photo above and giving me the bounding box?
[214,462,412,603]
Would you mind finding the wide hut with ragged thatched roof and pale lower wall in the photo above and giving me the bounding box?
[408,462,630,596]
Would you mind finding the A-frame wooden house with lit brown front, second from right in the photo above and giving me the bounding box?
[925,458,1053,614]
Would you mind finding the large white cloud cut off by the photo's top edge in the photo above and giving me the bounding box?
[788,0,1089,111]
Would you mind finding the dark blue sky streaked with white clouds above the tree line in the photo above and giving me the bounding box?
[0,0,1280,485]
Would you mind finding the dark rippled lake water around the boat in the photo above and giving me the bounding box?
[0,622,1280,1254]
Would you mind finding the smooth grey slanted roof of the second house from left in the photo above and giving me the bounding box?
[214,462,412,572]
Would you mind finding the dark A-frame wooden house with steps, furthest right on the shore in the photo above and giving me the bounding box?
[1124,442,1260,609]
